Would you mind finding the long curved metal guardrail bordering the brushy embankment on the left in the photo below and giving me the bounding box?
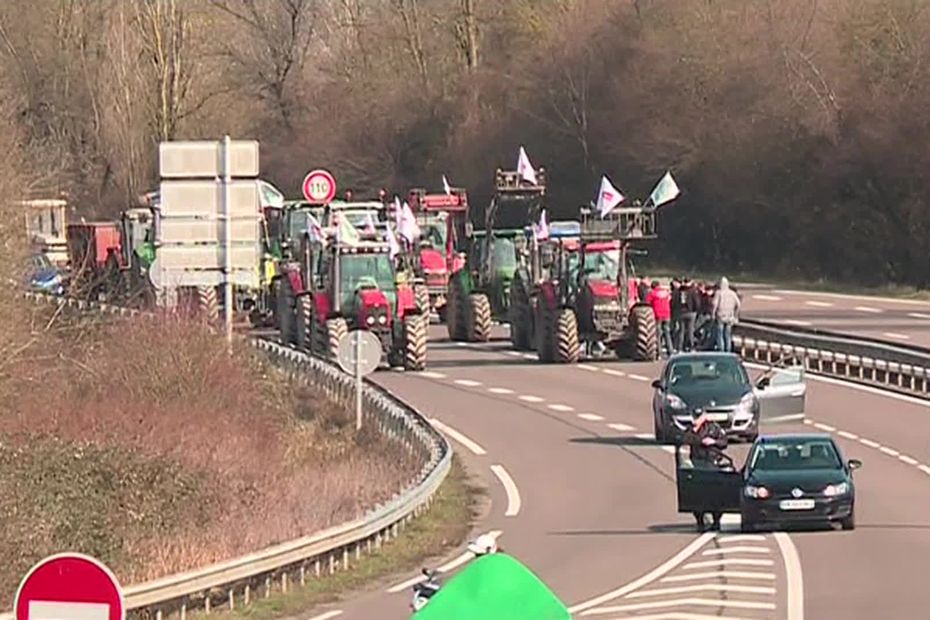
[13,293,452,620]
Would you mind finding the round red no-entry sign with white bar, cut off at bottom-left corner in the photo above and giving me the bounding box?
[13,553,126,620]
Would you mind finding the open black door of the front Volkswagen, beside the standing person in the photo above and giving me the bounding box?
[675,445,743,513]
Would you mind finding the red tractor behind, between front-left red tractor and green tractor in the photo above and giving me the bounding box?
[407,188,468,323]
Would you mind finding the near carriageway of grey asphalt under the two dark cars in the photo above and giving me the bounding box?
[311,322,930,620]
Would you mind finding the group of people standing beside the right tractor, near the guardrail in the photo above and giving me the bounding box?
[637,277,741,355]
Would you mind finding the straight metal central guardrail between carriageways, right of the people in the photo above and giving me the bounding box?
[733,320,930,399]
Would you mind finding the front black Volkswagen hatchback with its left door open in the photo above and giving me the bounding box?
[675,434,862,532]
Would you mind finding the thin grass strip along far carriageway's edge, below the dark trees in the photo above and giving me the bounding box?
[639,265,930,301]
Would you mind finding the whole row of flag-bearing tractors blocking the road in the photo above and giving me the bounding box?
[20,157,658,370]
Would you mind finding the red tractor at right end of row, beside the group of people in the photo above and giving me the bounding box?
[535,207,658,364]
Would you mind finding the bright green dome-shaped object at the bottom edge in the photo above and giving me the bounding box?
[412,553,571,620]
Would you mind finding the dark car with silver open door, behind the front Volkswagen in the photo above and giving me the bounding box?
[652,352,807,443]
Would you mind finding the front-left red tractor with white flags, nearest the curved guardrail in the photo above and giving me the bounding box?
[277,224,429,370]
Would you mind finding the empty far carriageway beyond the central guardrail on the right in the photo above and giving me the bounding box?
[740,286,930,347]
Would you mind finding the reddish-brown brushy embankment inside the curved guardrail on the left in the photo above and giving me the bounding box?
[0,309,419,601]
